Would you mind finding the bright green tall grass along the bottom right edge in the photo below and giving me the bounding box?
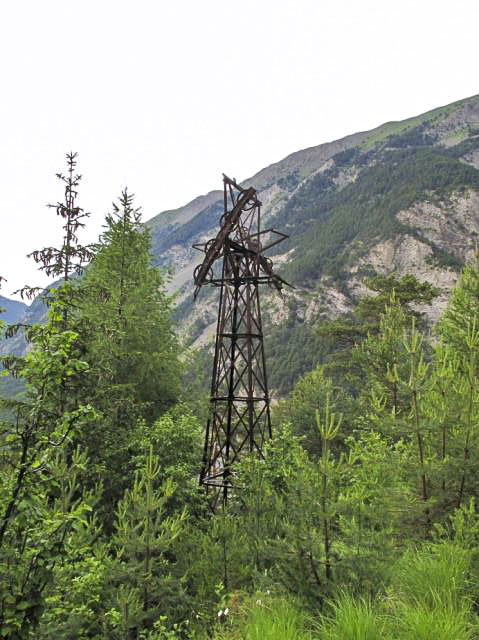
[204,543,479,640]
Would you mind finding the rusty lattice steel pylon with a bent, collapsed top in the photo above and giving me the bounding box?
[194,175,288,502]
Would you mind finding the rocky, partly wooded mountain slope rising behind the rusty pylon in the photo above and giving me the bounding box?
[146,95,479,393]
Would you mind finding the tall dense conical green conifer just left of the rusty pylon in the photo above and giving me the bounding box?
[78,190,180,513]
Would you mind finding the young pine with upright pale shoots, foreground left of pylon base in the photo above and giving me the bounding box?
[105,447,186,638]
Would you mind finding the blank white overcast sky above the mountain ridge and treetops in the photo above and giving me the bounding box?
[0,0,479,297]
